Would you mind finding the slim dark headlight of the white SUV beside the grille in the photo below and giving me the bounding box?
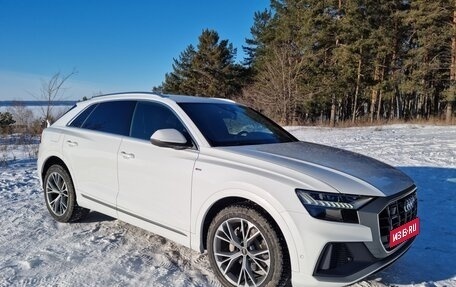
[296,189,372,223]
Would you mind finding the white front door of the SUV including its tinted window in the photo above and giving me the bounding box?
[117,102,198,245]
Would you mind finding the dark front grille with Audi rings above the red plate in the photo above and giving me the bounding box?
[378,191,418,251]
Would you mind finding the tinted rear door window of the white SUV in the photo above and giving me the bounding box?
[81,101,136,136]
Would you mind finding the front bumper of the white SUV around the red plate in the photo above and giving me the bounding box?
[289,186,417,286]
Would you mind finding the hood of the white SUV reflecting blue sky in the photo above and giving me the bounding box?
[223,142,413,196]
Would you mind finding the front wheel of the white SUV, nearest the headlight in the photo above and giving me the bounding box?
[207,205,289,287]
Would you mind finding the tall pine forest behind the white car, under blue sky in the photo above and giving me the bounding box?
[159,0,456,126]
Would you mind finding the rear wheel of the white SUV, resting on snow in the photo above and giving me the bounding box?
[43,164,89,222]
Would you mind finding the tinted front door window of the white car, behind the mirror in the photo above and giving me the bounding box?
[130,102,186,140]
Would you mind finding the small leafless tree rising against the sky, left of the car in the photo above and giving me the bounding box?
[32,69,78,124]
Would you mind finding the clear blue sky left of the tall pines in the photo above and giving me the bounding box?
[0,0,269,101]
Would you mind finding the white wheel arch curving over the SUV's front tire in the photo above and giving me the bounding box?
[196,192,299,270]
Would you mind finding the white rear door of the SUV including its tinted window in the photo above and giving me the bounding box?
[63,101,136,216]
